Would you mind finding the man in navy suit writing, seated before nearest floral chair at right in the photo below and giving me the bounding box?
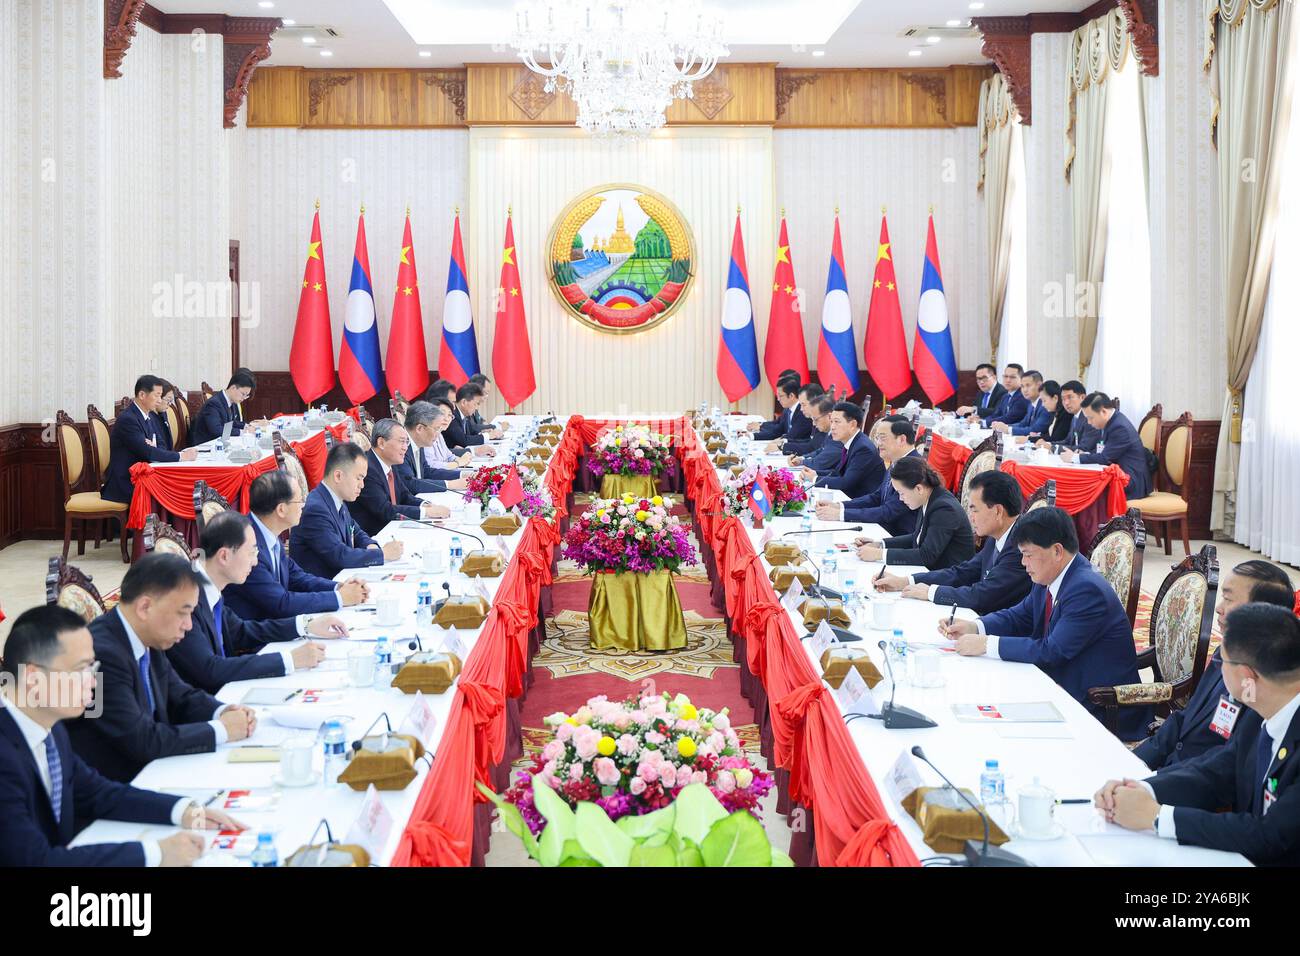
[939,507,1151,740]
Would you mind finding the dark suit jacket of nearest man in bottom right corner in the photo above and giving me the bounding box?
[1147,714,1300,866]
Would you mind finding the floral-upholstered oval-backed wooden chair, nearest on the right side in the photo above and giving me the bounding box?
[1088,545,1218,734]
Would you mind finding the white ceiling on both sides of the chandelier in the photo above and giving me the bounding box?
[152,0,1092,68]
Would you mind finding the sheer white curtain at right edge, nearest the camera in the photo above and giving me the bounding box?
[1234,78,1300,564]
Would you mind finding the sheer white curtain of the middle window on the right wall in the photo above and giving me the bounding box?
[1088,57,1149,421]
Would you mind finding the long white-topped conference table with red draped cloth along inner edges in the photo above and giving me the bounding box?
[74,416,1245,866]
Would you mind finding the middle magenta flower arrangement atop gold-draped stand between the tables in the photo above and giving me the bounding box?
[564,494,696,574]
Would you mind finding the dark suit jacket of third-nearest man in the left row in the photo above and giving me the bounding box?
[166,588,298,693]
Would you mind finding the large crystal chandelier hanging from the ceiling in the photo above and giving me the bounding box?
[511,0,728,137]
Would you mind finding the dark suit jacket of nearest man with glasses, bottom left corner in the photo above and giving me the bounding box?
[0,705,179,866]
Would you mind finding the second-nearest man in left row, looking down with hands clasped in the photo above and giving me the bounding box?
[68,554,257,783]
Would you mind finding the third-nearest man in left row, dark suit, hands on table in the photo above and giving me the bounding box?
[166,511,347,693]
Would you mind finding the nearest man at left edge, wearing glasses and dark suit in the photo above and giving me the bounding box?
[0,605,244,866]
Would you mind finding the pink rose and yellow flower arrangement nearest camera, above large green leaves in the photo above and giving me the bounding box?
[491,693,772,836]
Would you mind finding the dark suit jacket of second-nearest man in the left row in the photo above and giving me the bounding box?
[68,609,221,783]
